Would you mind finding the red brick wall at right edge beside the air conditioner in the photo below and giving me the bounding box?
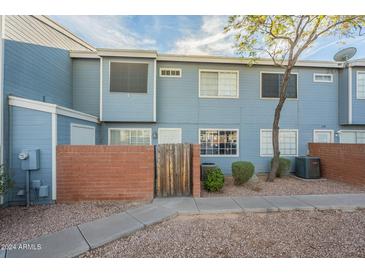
[309,143,365,185]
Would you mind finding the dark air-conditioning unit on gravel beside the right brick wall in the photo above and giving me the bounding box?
[295,156,321,179]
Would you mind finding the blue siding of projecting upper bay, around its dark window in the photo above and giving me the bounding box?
[102,58,154,122]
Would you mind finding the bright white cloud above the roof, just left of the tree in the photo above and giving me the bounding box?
[170,16,234,55]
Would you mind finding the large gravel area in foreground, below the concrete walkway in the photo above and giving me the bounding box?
[82,210,365,257]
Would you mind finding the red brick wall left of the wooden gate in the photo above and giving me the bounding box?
[57,145,154,201]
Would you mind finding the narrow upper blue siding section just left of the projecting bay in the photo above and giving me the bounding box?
[72,59,100,117]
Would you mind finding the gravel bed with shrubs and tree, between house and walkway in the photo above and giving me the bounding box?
[202,175,365,197]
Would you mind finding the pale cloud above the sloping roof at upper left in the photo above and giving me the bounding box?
[54,16,156,49]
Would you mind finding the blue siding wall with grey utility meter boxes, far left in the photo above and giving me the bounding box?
[9,107,52,203]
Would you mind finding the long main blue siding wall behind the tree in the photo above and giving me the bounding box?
[101,62,339,174]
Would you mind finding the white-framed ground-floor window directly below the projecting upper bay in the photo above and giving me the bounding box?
[109,128,151,145]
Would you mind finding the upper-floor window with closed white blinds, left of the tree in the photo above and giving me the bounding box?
[199,70,238,98]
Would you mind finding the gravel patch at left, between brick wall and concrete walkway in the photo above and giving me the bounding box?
[0,201,141,247]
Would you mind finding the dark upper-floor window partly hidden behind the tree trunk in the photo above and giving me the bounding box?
[261,72,298,99]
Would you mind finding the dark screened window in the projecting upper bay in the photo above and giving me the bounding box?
[110,62,148,93]
